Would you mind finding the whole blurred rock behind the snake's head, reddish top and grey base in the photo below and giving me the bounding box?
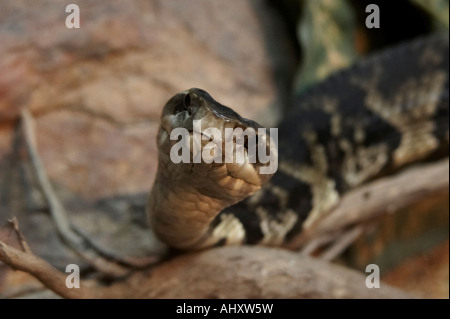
[0,0,294,296]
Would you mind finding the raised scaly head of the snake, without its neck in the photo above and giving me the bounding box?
[157,88,277,205]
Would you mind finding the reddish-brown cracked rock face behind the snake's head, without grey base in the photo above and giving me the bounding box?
[0,0,292,199]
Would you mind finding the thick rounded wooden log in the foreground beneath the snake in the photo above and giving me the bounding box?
[139,246,411,298]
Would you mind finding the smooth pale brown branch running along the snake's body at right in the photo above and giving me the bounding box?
[289,158,449,252]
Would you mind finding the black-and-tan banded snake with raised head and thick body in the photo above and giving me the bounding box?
[147,34,449,250]
